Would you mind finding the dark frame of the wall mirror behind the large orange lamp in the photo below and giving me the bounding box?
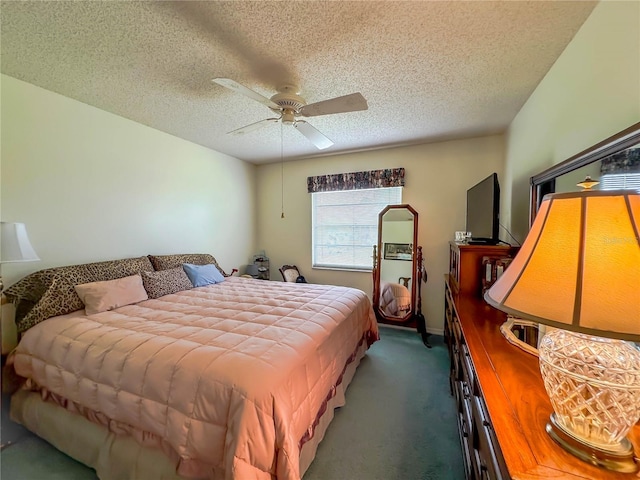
[529,122,640,227]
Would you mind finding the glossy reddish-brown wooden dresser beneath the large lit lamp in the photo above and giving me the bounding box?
[444,275,640,480]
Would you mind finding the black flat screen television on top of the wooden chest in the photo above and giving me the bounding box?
[466,173,500,245]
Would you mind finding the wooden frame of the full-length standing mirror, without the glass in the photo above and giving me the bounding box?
[373,203,422,327]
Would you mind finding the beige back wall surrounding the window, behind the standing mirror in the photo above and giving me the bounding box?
[257,135,504,333]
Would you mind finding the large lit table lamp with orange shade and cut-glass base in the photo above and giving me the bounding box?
[484,189,640,472]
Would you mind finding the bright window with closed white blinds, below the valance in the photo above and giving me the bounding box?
[311,187,402,270]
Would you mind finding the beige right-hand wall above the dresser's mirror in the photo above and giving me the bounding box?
[502,1,640,238]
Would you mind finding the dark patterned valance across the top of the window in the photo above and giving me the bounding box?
[307,168,404,193]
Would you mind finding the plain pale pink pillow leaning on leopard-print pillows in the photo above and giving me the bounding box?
[75,275,149,315]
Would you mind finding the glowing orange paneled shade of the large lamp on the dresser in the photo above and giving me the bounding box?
[484,190,640,342]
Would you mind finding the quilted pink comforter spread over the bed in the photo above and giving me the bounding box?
[13,277,378,480]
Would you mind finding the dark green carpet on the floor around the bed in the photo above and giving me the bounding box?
[0,327,464,480]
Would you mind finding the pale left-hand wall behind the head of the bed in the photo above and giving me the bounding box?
[1,75,256,285]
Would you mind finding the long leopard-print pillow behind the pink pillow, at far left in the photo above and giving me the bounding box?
[4,257,153,333]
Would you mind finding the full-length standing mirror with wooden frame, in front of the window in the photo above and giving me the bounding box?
[373,205,420,326]
